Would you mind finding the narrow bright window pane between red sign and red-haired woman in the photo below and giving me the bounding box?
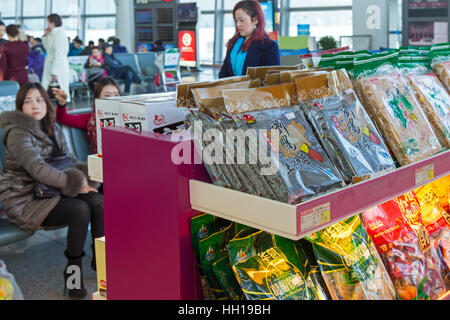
[198,14,214,63]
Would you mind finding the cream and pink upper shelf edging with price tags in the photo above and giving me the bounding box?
[190,151,450,240]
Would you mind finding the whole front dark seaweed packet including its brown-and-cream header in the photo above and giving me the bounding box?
[223,83,342,204]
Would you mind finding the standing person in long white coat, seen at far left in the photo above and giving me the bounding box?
[42,14,70,102]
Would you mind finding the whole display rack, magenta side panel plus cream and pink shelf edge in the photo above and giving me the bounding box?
[93,128,450,300]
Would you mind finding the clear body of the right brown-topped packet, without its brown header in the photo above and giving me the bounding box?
[305,90,395,183]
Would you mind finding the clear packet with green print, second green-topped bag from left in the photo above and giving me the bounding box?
[406,66,450,148]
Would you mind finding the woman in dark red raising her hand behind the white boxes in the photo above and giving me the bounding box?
[53,77,120,154]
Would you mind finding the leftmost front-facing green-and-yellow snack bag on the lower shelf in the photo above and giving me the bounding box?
[229,231,326,300]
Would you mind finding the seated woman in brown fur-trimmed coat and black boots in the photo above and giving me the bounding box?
[0,83,105,298]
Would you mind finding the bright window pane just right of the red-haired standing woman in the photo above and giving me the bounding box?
[289,10,353,42]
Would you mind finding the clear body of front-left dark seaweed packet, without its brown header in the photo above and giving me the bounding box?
[235,107,343,204]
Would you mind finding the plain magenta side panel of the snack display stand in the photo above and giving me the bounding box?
[102,128,210,300]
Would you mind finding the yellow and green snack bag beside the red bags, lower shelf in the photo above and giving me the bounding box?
[306,216,396,300]
